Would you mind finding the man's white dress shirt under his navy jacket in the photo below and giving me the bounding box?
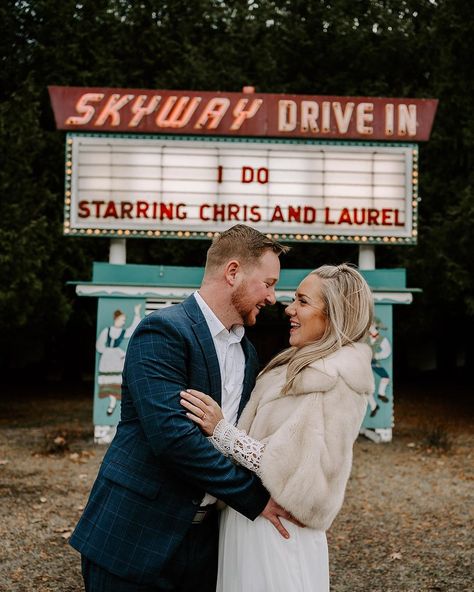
[194,292,245,506]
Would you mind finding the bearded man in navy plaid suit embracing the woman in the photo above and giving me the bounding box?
[71,225,291,592]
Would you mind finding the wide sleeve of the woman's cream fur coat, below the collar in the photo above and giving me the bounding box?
[261,379,367,530]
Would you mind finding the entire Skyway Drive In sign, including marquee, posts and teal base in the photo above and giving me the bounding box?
[49,87,437,443]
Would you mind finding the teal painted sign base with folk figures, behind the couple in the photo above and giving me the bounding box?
[74,263,419,443]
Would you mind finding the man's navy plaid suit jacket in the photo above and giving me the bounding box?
[70,296,269,583]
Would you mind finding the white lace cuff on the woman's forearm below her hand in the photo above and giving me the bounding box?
[209,419,265,476]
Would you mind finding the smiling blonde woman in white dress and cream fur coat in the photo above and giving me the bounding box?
[182,265,373,592]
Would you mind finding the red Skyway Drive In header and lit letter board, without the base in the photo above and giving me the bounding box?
[50,87,436,244]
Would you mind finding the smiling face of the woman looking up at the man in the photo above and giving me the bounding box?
[285,275,327,347]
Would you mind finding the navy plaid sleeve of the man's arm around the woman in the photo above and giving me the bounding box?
[124,316,269,520]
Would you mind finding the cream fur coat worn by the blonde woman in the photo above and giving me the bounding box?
[238,343,373,530]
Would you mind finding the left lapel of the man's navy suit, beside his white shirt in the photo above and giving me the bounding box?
[183,296,222,405]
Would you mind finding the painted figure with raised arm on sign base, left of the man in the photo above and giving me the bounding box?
[96,304,141,416]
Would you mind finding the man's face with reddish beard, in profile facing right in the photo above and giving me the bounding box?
[232,251,280,327]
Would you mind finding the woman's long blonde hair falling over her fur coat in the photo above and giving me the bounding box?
[261,263,374,394]
